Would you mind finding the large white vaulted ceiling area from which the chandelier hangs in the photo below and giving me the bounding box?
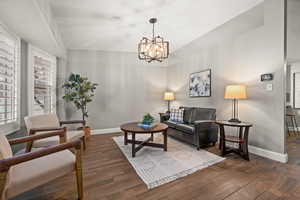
[50,0,263,52]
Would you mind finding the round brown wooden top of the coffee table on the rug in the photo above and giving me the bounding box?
[121,122,168,133]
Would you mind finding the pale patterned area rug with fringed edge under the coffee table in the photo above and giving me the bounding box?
[113,134,224,189]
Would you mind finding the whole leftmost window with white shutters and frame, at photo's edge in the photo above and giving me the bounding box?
[0,23,20,134]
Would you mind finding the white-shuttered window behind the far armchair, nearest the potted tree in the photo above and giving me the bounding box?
[28,46,56,115]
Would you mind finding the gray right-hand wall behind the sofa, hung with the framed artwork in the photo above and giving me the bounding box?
[168,0,285,153]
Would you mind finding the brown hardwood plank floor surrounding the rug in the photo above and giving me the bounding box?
[11,134,300,200]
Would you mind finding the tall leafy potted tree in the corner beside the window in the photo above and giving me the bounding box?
[63,73,98,137]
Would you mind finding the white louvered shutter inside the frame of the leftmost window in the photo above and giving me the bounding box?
[0,26,19,125]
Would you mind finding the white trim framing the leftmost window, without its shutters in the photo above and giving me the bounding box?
[0,22,21,135]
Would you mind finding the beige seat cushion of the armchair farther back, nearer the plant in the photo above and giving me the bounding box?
[33,130,84,148]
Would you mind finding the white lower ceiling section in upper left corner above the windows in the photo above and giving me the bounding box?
[0,0,66,57]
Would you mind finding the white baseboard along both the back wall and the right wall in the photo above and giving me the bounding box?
[92,128,288,163]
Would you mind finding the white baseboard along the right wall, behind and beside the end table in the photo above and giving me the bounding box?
[226,143,288,163]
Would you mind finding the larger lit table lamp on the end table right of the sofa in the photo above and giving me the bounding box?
[224,85,247,123]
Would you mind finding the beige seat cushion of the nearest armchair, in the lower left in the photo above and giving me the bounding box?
[6,150,76,198]
